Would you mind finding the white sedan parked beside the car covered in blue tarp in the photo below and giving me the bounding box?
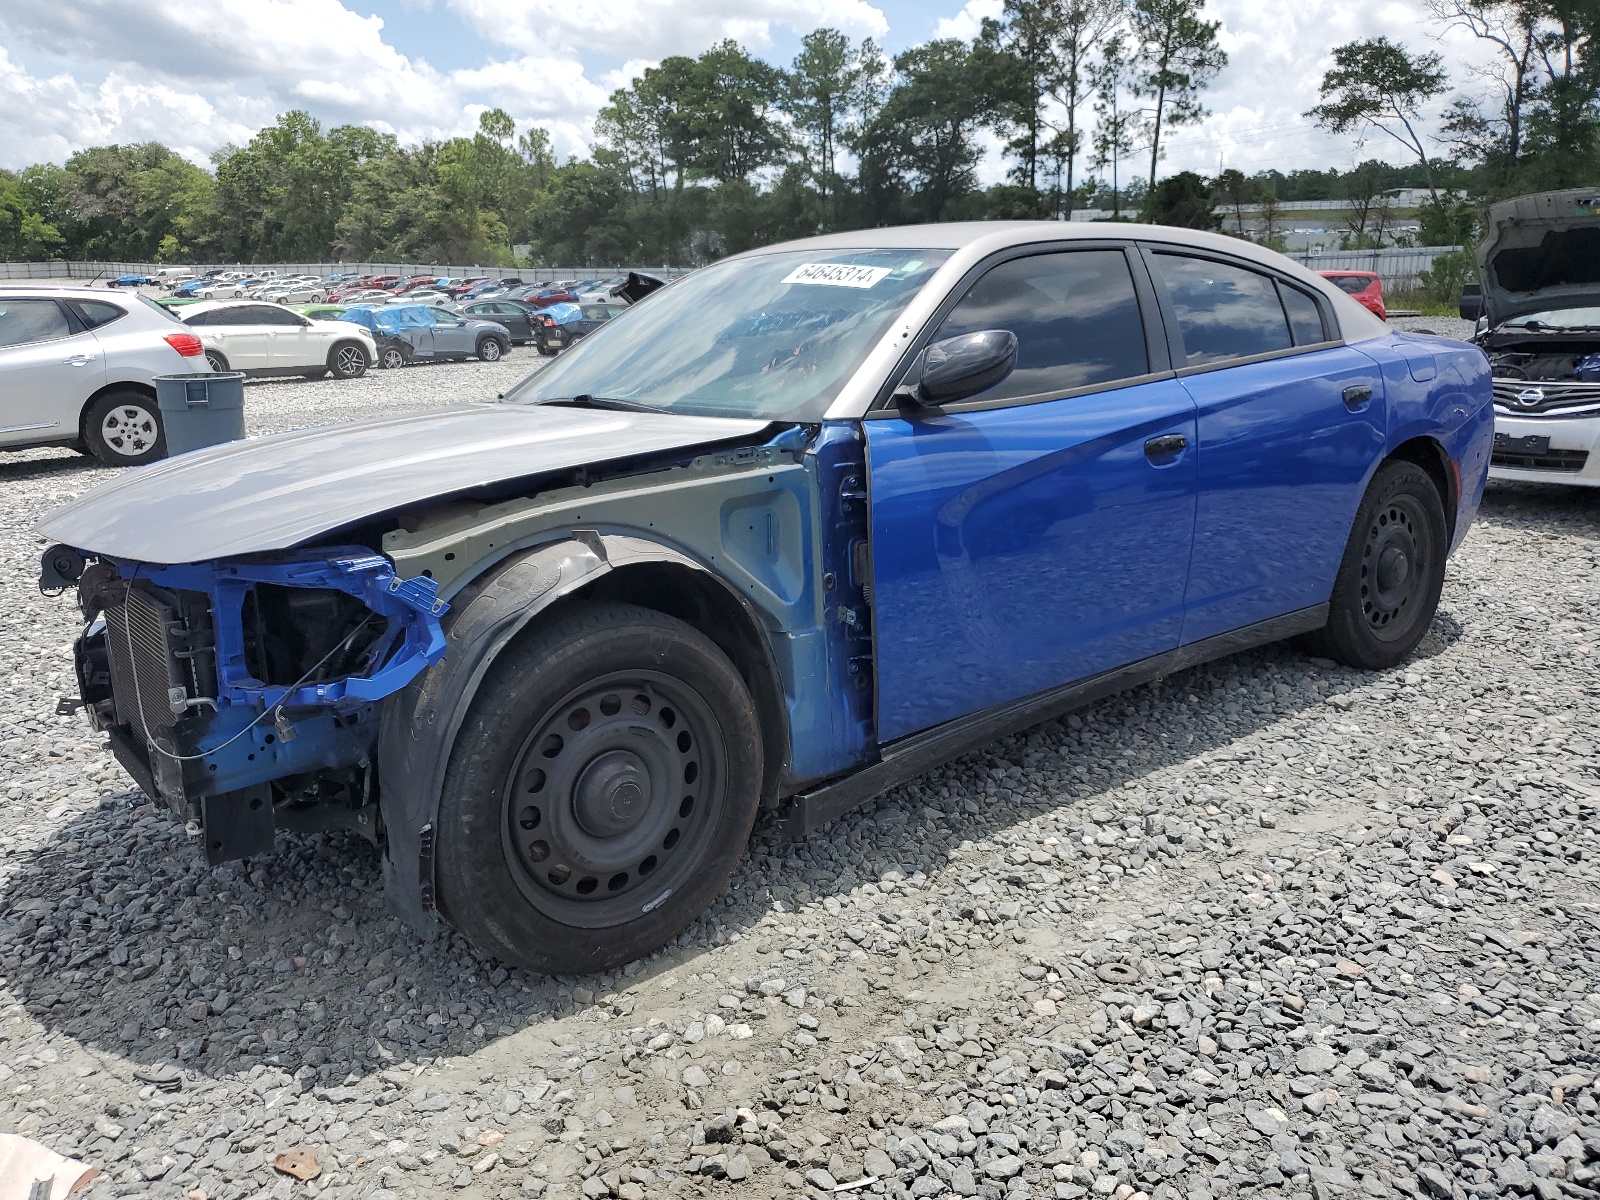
[182,301,378,379]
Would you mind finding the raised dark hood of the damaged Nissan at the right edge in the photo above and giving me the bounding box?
[1478,187,1600,326]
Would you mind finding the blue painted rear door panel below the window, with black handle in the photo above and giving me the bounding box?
[1182,346,1387,643]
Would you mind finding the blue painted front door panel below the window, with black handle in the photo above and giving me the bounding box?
[862,379,1197,742]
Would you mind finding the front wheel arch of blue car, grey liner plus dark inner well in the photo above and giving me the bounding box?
[378,531,789,931]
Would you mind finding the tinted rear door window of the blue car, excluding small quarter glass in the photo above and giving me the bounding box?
[1154,253,1291,366]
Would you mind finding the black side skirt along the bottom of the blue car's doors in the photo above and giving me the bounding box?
[782,605,1328,840]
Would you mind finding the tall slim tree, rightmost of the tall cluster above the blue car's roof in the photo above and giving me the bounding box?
[1131,0,1227,181]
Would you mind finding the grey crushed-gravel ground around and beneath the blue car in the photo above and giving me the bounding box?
[0,336,1600,1200]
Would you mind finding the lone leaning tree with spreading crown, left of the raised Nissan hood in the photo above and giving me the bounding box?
[1306,37,1448,200]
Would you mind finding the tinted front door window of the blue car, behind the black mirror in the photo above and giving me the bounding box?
[934,250,1150,400]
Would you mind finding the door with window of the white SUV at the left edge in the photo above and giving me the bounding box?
[0,296,106,445]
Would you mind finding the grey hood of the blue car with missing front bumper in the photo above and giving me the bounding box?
[37,405,768,563]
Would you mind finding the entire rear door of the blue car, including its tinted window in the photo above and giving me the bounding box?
[1146,246,1386,643]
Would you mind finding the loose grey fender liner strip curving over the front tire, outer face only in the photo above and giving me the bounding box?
[378,530,761,934]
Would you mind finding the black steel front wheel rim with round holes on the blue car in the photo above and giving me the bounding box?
[501,672,728,928]
